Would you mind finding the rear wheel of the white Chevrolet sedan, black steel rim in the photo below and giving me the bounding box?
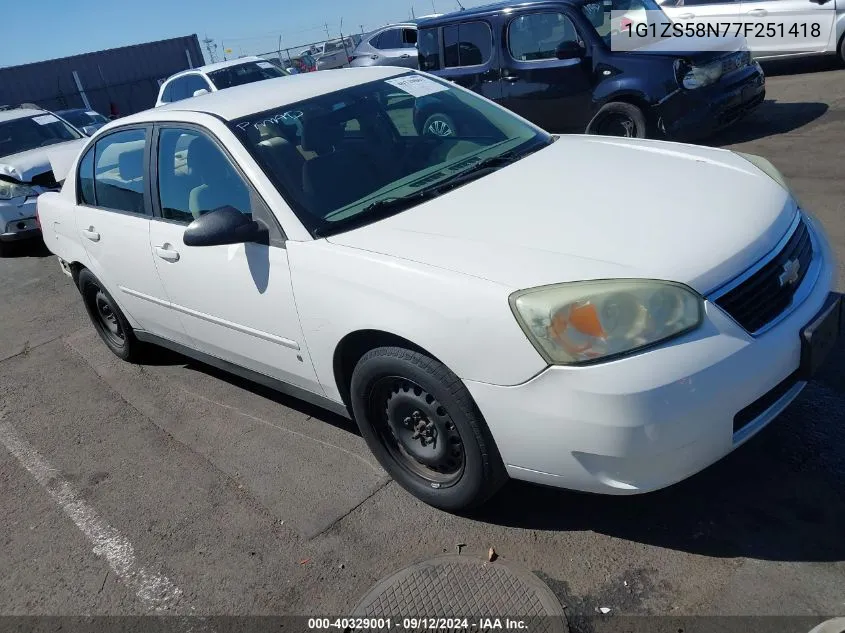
[77,268,141,362]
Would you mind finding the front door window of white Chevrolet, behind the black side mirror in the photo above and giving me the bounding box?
[158,128,252,224]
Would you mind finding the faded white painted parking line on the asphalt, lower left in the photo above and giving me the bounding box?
[0,411,184,613]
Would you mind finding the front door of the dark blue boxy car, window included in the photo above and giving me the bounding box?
[501,9,593,133]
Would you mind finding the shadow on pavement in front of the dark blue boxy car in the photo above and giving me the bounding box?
[705,99,830,147]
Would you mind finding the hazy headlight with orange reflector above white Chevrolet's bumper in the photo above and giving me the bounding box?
[510,279,703,365]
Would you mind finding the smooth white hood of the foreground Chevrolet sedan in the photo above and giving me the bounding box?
[329,136,796,292]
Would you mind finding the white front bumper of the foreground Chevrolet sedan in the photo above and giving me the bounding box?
[465,212,836,494]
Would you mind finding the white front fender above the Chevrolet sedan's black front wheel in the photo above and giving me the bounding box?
[288,240,546,401]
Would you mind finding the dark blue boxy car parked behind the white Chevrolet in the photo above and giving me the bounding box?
[418,0,765,140]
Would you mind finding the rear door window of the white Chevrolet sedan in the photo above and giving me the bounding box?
[91,130,146,214]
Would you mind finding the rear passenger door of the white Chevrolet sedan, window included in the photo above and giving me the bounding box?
[75,127,187,343]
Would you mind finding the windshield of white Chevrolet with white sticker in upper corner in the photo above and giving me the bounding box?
[230,73,552,236]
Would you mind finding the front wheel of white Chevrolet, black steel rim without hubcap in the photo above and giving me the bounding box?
[350,347,507,512]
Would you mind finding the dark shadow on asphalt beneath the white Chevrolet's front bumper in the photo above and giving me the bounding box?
[473,338,845,561]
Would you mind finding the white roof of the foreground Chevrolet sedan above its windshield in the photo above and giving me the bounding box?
[134,66,412,124]
